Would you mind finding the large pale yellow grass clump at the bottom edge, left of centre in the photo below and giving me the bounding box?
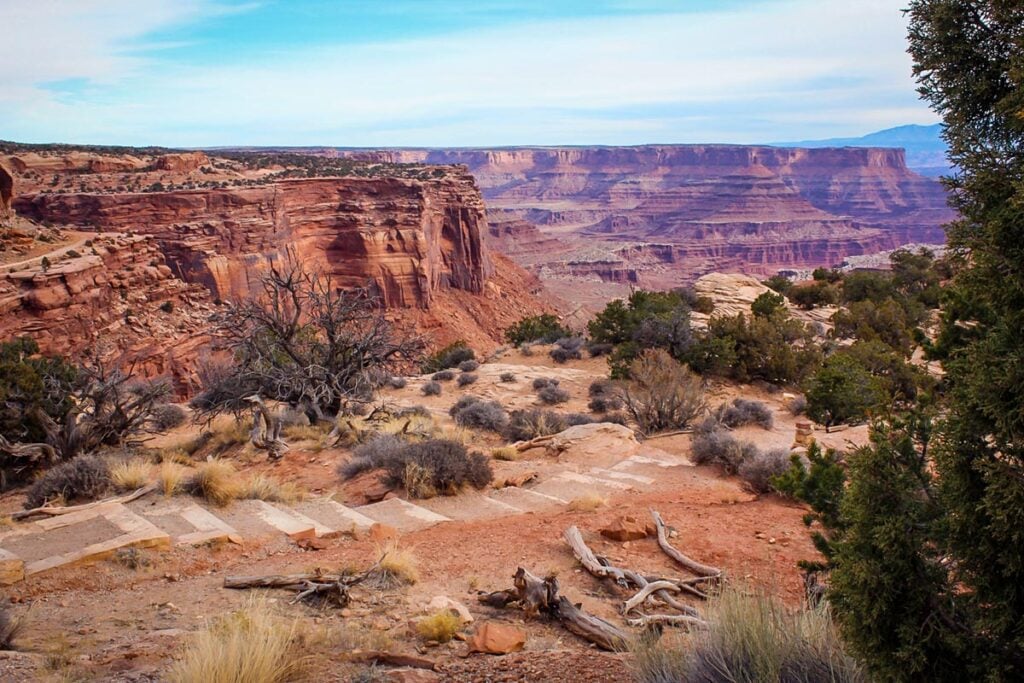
[169,601,308,683]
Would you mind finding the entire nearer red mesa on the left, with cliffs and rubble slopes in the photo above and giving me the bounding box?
[0,153,546,395]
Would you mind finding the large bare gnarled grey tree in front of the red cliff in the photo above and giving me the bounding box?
[194,266,423,421]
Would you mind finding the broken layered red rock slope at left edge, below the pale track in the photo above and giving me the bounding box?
[0,234,213,395]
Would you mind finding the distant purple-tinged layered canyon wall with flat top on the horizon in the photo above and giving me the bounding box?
[333,145,953,303]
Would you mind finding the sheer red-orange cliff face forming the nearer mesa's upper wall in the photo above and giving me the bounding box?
[18,172,493,308]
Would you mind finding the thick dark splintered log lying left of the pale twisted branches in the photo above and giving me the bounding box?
[478,567,630,652]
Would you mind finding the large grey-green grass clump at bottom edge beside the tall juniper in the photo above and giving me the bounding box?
[634,587,867,683]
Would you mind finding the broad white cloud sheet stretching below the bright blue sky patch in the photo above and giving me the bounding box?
[0,0,934,145]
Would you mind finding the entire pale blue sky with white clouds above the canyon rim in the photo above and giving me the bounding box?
[0,0,936,146]
